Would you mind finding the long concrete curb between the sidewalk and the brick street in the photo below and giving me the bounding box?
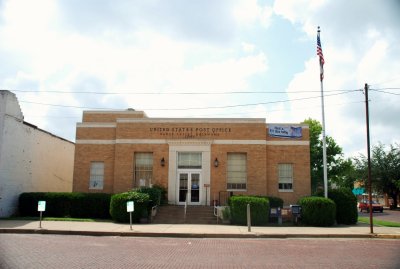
[0,229,400,239]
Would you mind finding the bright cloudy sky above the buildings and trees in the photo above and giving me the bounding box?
[0,0,400,156]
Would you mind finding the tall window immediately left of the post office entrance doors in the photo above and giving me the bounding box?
[134,152,153,187]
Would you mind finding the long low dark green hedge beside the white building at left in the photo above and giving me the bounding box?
[18,192,111,219]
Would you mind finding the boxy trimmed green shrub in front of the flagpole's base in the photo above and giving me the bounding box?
[299,197,336,227]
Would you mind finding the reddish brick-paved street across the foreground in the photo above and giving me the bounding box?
[0,234,400,269]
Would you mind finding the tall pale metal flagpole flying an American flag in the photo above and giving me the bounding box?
[317,26,328,198]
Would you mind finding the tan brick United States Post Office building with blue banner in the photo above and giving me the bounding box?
[73,109,311,205]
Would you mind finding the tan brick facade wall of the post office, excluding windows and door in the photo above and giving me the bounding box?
[73,112,311,204]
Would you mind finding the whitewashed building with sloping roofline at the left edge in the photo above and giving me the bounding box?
[0,90,75,217]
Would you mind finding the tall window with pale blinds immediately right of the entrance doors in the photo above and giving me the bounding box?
[226,153,247,190]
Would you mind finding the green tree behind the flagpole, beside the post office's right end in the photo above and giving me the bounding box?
[304,118,355,192]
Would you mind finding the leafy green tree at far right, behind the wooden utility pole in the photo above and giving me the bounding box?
[354,143,400,207]
